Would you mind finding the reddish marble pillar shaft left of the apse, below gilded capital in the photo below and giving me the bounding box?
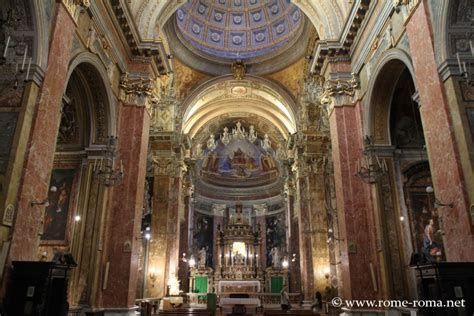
[102,104,150,309]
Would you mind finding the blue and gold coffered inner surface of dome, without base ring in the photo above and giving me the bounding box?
[176,0,303,59]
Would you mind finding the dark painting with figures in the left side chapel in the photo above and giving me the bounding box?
[41,169,75,241]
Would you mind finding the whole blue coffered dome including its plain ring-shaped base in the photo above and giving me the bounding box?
[165,0,315,75]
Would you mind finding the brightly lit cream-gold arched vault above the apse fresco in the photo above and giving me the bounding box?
[181,75,296,139]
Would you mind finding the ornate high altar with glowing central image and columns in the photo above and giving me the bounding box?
[190,203,288,294]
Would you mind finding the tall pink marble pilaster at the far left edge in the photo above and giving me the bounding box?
[8,4,75,262]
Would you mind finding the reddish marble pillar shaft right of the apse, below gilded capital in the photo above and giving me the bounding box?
[330,103,380,299]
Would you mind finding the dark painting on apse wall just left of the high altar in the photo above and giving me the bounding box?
[193,212,214,266]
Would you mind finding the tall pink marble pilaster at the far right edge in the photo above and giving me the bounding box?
[406,1,474,261]
